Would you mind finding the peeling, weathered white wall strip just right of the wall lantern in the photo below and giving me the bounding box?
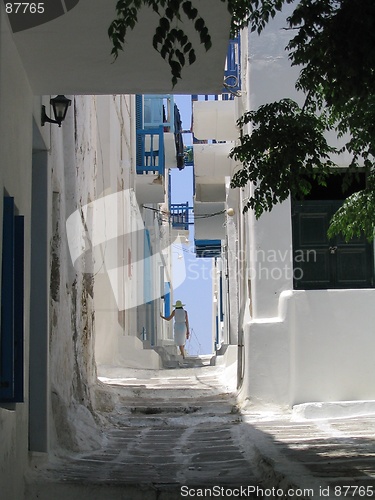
[48,96,104,450]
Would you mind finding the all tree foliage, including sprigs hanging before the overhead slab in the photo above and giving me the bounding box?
[108,0,375,239]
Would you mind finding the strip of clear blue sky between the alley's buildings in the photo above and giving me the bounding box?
[171,96,213,355]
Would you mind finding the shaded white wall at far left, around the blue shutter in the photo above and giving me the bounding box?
[0,4,33,499]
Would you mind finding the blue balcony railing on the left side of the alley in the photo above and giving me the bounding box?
[136,125,165,175]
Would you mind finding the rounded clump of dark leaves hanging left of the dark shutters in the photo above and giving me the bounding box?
[230,99,336,217]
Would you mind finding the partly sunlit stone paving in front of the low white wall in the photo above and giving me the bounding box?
[244,414,375,500]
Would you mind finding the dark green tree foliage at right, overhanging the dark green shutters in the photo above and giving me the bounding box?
[232,0,375,240]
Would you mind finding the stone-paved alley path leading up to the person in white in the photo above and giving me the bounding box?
[26,360,262,500]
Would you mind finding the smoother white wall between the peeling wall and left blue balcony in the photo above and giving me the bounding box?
[90,96,159,373]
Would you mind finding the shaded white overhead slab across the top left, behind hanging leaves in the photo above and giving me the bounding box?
[10,0,230,95]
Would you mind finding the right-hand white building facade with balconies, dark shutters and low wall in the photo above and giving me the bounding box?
[194,8,375,407]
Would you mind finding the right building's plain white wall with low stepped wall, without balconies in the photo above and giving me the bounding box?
[236,6,375,406]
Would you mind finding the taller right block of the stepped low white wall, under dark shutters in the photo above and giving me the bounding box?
[291,290,375,404]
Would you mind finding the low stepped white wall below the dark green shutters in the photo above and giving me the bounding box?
[241,289,375,406]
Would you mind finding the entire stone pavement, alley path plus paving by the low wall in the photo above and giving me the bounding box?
[25,366,375,500]
